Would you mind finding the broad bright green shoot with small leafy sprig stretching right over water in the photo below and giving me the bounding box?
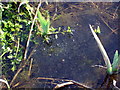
[37,11,72,42]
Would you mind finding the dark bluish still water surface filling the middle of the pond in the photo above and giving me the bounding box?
[19,3,120,88]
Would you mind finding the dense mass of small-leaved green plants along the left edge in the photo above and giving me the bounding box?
[0,3,30,74]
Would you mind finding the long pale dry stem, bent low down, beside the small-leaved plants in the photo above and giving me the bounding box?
[10,2,41,86]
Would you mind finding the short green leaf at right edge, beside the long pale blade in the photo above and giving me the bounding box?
[112,50,120,72]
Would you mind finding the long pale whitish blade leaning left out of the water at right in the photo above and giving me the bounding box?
[89,25,112,74]
